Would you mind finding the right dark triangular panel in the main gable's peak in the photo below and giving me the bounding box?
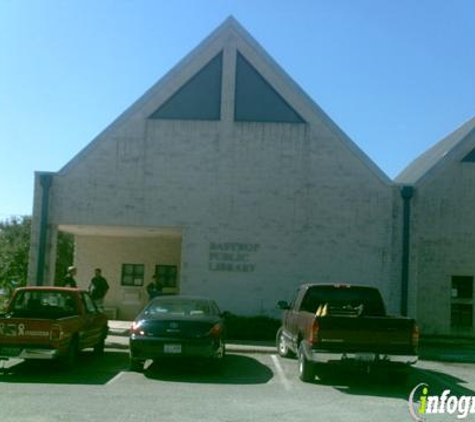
[234,52,305,123]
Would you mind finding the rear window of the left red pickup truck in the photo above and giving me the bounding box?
[11,291,78,318]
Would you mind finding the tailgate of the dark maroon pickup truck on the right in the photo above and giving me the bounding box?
[313,316,414,354]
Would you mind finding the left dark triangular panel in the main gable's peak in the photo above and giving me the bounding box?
[150,53,223,120]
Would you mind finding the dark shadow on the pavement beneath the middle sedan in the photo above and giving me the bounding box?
[145,354,274,384]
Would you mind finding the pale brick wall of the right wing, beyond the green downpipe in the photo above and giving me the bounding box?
[411,134,475,335]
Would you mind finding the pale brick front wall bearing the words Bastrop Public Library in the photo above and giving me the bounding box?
[27,21,398,315]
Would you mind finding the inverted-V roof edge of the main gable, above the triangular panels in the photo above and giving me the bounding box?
[60,16,392,185]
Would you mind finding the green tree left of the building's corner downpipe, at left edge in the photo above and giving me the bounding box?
[0,216,31,288]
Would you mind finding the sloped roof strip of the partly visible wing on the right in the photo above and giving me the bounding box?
[395,117,475,185]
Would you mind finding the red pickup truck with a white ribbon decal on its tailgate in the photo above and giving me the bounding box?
[0,287,108,365]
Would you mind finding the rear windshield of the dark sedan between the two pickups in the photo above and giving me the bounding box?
[144,299,217,317]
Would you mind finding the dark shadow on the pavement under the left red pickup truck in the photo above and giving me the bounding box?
[0,351,129,385]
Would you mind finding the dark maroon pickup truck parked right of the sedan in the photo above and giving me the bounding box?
[277,284,419,382]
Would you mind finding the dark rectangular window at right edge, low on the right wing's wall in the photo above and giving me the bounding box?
[450,276,473,328]
